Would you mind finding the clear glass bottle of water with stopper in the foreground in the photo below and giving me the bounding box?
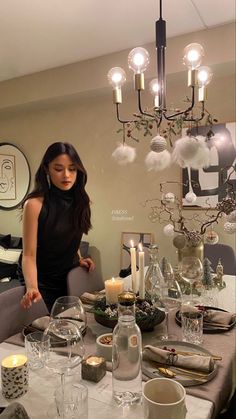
[112,292,142,405]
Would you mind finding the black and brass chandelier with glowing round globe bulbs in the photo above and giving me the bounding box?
[108,0,212,128]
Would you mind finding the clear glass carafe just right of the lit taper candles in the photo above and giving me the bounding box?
[145,244,164,301]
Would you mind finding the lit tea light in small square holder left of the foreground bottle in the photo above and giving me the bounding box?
[82,356,106,383]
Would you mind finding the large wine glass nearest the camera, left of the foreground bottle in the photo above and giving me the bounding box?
[44,318,85,388]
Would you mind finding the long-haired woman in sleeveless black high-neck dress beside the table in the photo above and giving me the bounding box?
[18,142,94,311]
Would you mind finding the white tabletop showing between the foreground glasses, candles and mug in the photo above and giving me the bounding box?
[0,342,212,419]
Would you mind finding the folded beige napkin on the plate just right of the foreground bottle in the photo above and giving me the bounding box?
[143,345,214,372]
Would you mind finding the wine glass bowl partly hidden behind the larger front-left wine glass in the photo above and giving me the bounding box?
[50,295,87,335]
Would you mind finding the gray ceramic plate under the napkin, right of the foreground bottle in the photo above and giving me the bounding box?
[142,340,218,387]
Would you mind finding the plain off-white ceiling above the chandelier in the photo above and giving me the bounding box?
[0,0,235,81]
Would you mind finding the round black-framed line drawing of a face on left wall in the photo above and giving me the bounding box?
[0,142,30,210]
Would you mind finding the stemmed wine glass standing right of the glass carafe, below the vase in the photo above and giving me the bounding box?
[152,271,182,340]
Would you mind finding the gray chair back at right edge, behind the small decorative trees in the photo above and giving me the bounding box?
[204,243,236,275]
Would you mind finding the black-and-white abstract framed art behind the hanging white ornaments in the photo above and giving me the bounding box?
[182,122,236,208]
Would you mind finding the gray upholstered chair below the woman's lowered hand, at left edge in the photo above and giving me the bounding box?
[0,286,49,342]
